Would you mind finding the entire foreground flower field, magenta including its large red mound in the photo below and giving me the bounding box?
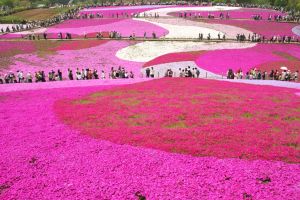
[0,79,300,199]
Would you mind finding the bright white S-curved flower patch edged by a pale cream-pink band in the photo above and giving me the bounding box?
[134,18,223,39]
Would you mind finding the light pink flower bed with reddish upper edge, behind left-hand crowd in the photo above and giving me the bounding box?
[0,40,143,77]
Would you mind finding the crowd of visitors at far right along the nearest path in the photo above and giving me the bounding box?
[227,68,299,82]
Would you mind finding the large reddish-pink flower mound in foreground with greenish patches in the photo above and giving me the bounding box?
[55,79,300,163]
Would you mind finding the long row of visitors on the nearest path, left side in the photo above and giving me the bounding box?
[0,66,134,84]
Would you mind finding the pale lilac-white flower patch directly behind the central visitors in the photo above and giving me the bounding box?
[141,61,222,79]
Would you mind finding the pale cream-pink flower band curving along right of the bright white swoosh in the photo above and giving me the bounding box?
[139,18,252,39]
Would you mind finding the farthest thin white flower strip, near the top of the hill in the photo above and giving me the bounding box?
[140,6,241,17]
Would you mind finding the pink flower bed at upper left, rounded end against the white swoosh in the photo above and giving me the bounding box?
[0,19,168,39]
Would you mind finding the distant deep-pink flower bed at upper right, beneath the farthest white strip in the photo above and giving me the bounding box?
[170,8,286,20]
